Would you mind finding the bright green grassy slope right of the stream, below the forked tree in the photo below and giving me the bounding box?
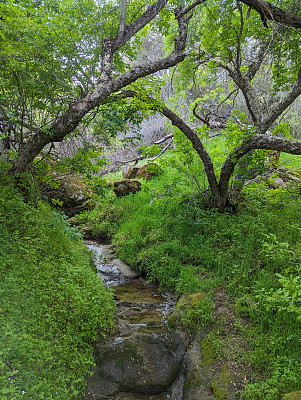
[79,158,301,400]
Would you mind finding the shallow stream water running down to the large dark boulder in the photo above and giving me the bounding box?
[86,241,175,337]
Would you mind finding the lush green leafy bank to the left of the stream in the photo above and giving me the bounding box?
[0,165,114,400]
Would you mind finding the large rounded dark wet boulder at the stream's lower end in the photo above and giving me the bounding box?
[89,332,188,395]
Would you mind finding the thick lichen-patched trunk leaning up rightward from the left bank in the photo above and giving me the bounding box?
[13,0,187,172]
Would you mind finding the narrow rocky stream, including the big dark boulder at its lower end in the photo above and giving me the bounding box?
[85,241,188,400]
